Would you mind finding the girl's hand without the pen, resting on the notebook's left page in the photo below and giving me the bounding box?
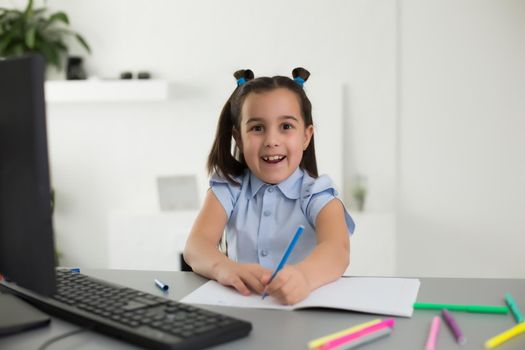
[214,260,271,295]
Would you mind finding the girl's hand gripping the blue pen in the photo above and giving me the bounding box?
[262,265,311,305]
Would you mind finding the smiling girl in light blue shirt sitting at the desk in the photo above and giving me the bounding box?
[184,68,354,304]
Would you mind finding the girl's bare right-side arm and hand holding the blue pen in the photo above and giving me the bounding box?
[263,198,350,304]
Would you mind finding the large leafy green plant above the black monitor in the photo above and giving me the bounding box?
[0,0,91,69]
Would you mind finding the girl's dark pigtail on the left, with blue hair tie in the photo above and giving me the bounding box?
[207,69,254,184]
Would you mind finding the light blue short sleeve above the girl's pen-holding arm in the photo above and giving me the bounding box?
[303,175,355,234]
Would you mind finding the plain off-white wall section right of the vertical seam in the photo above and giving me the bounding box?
[398,0,525,278]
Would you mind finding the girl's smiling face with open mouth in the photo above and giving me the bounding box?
[234,88,313,184]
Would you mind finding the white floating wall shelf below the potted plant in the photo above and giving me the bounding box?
[45,79,168,103]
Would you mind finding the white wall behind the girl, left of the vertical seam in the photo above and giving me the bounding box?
[16,0,395,267]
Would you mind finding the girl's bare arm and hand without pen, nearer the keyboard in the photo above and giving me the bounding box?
[183,190,267,295]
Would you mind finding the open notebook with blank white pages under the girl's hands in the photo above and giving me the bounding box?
[181,277,420,317]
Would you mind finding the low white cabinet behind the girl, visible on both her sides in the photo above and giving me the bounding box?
[108,210,396,276]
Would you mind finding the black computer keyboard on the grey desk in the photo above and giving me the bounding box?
[4,270,252,349]
